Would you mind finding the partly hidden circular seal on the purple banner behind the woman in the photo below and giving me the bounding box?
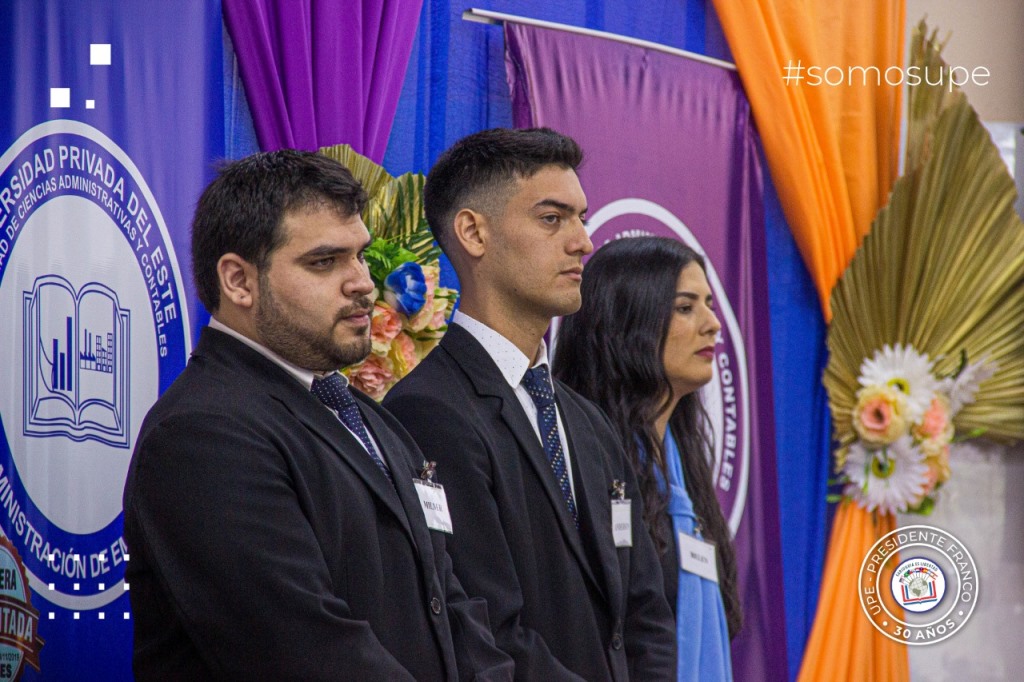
[561,193,751,535]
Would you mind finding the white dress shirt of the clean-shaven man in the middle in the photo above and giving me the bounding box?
[452,310,575,499]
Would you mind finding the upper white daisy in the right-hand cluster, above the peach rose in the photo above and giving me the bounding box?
[857,343,940,422]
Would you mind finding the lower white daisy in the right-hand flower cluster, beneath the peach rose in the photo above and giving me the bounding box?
[843,435,929,514]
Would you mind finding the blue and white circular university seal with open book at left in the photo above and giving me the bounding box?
[0,120,190,611]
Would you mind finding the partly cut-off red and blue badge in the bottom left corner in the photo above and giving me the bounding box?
[0,538,43,682]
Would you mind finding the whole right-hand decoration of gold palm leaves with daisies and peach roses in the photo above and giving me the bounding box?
[822,22,1024,518]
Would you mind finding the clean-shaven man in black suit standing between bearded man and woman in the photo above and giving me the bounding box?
[385,129,676,681]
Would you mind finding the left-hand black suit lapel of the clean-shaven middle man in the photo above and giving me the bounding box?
[440,325,617,594]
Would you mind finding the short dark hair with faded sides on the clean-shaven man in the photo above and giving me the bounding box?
[423,128,583,256]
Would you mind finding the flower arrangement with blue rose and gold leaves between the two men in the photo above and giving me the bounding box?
[319,144,459,400]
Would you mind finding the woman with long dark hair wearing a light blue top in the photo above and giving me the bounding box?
[554,237,742,680]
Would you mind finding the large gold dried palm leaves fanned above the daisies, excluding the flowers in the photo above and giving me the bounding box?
[823,22,1024,445]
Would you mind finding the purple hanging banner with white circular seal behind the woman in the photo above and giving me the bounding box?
[505,24,786,680]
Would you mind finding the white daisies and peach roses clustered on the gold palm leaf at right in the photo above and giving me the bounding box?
[837,344,995,514]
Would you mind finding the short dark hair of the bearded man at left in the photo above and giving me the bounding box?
[191,150,367,312]
